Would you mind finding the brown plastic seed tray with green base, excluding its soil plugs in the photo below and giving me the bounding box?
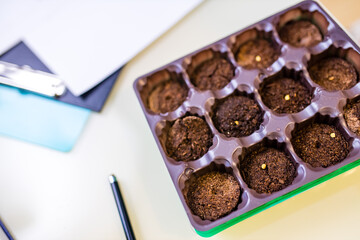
[134,1,360,237]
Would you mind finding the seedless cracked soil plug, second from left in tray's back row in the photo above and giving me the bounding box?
[190,58,234,91]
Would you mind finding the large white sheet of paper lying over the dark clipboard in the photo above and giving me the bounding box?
[0,0,201,95]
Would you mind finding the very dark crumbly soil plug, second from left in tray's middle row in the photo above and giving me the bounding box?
[213,95,263,137]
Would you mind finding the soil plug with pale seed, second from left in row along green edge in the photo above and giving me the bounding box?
[240,148,297,193]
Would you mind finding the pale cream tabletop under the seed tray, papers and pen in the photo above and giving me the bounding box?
[0,0,360,240]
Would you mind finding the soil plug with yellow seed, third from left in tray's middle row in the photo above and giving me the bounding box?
[260,78,311,113]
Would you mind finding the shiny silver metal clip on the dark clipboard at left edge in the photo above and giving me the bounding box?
[0,61,66,97]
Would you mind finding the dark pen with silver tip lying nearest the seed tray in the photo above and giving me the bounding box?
[109,175,135,240]
